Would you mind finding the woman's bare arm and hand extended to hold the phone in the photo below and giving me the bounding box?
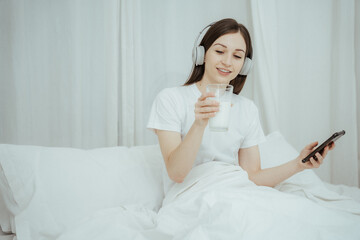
[238,142,335,187]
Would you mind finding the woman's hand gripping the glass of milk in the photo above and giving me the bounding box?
[194,92,219,127]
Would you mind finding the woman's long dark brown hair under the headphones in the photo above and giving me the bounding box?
[184,18,253,94]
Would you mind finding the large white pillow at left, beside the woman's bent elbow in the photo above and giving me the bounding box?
[0,144,163,239]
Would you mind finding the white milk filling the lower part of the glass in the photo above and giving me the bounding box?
[209,102,231,132]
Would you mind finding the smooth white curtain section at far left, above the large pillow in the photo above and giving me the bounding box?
[0,0,119,148]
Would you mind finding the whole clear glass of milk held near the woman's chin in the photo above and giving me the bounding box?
[206,84,233,132]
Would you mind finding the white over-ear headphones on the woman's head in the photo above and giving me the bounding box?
[192,23,253,75]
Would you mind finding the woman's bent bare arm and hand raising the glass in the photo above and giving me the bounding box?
[156,93,219,183]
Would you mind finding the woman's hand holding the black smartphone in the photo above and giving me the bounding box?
[297,142,335,170]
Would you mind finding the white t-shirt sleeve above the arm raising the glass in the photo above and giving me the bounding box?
[147,89,182,133]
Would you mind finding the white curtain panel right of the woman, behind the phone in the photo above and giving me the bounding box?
[251,0,360,186]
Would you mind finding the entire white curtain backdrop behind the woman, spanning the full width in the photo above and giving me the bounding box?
[0,0,360,185]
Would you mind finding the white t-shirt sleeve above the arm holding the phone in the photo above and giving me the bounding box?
[241,102,266,148]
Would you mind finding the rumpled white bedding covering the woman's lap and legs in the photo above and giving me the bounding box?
[58,162,360,240]
